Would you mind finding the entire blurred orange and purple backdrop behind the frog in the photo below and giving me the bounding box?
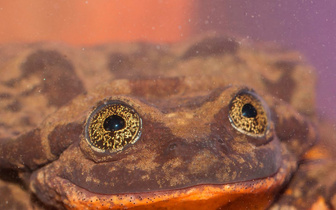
[0,0,336,119]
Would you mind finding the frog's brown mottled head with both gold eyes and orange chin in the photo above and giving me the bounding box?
[0,78,316,209]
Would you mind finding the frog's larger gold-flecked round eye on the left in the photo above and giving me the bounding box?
[85,101,142,152]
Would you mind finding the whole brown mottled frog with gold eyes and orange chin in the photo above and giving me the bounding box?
[0,35,336,209]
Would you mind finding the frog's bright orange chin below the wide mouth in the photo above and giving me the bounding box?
[42,158,296,209]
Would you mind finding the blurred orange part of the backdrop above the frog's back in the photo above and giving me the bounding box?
[0,0,197,45]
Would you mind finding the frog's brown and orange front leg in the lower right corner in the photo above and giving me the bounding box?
[271,121,336,210]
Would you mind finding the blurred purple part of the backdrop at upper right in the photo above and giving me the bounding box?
[196,0,336,119]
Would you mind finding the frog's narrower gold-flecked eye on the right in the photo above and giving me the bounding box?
[229,91,268,137]
